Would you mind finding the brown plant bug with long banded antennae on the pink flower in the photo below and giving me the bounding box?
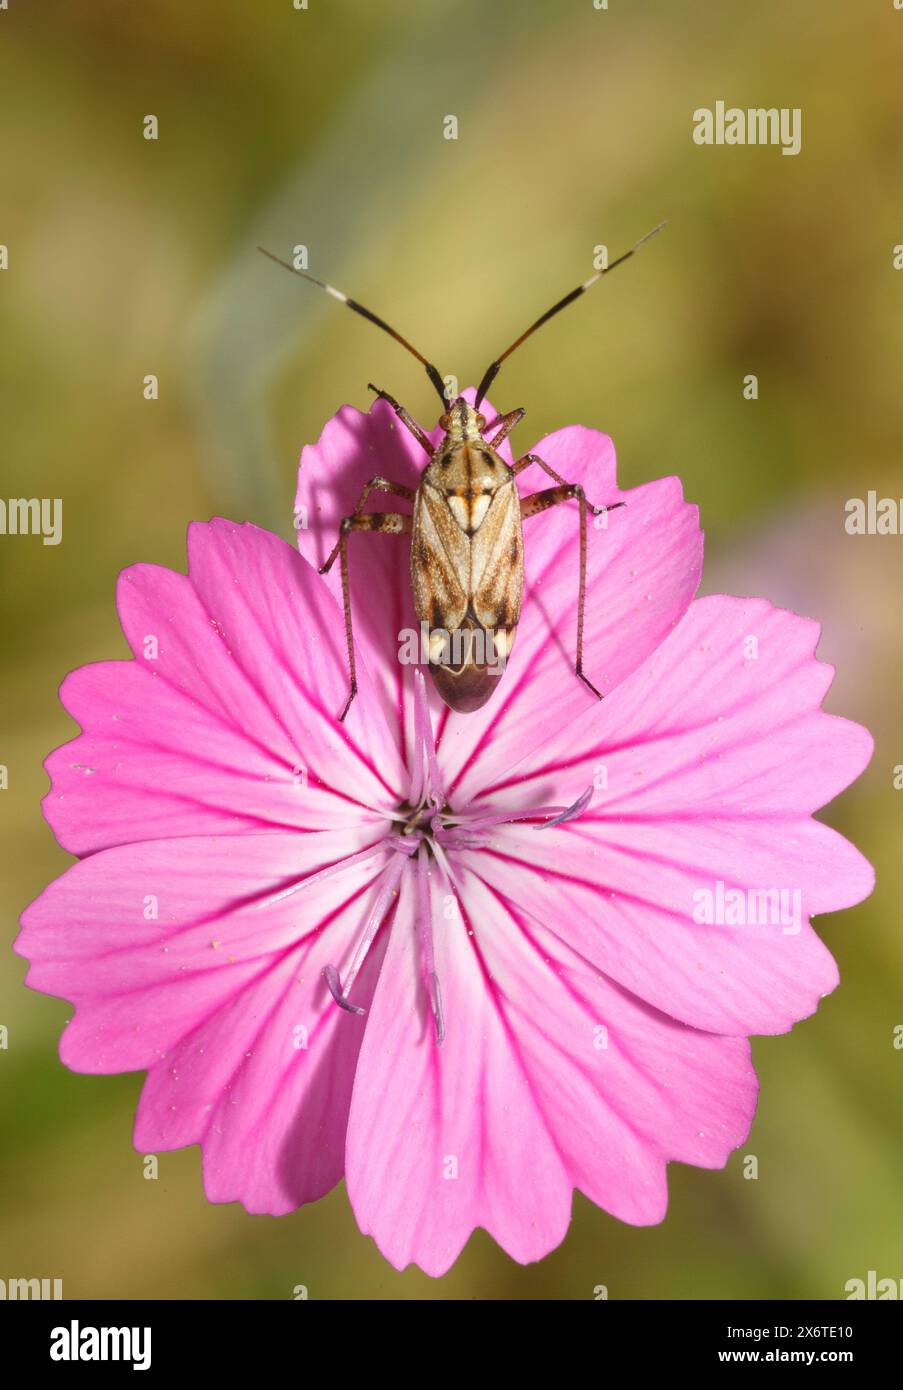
[258,222,665,720]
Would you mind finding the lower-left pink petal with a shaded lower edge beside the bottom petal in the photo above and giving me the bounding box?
[15,833,394,1212]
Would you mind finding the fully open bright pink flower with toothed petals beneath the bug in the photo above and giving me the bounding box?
[17,403,872,1275]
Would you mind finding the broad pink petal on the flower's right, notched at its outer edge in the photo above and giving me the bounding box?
[458,596,874,1033]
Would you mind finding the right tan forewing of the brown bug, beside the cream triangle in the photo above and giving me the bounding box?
[471,482,524,631]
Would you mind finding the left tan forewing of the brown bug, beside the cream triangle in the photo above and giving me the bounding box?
[411,484,471,632]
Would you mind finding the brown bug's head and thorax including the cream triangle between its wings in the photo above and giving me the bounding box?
[422,398,511,535]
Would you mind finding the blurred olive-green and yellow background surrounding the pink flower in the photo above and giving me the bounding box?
[0,0,903,1298]
